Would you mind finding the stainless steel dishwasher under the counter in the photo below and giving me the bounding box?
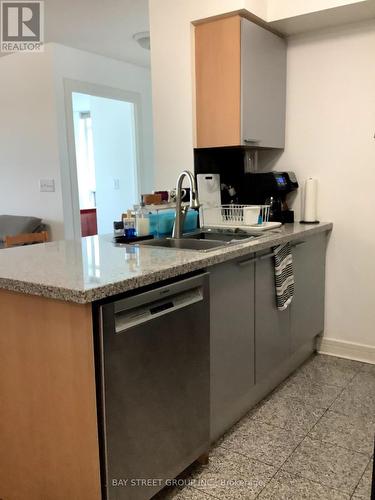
[99,274,210,500]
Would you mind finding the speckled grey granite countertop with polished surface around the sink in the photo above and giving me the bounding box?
[0,223,332,304]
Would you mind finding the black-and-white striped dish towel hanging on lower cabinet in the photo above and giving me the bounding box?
[273,243,294,311]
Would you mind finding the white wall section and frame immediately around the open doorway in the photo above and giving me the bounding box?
[50,44,154,237]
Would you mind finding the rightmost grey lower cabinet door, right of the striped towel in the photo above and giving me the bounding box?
[291,233,327,352]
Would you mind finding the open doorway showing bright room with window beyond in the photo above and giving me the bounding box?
[70,83,139,236]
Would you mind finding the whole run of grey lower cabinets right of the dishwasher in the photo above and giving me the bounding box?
[210,232,327,442]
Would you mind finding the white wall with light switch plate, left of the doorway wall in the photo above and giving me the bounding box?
[0,50,64,239]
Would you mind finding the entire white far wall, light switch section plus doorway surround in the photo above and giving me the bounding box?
[0,44,154,239]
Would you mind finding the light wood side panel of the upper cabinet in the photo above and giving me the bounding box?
[195,16,241,148]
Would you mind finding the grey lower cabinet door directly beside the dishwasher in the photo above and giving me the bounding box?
[210,255,255,442]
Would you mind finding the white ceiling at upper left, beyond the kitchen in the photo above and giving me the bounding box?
[45,0,150,66]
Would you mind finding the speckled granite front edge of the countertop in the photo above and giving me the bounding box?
[0,223,333,304]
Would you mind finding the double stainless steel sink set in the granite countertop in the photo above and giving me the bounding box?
[137,230,264,252]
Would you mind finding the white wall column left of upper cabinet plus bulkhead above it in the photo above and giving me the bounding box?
[149,0,374,189]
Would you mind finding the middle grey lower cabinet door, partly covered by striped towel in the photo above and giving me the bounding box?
[255,249,290,384]
